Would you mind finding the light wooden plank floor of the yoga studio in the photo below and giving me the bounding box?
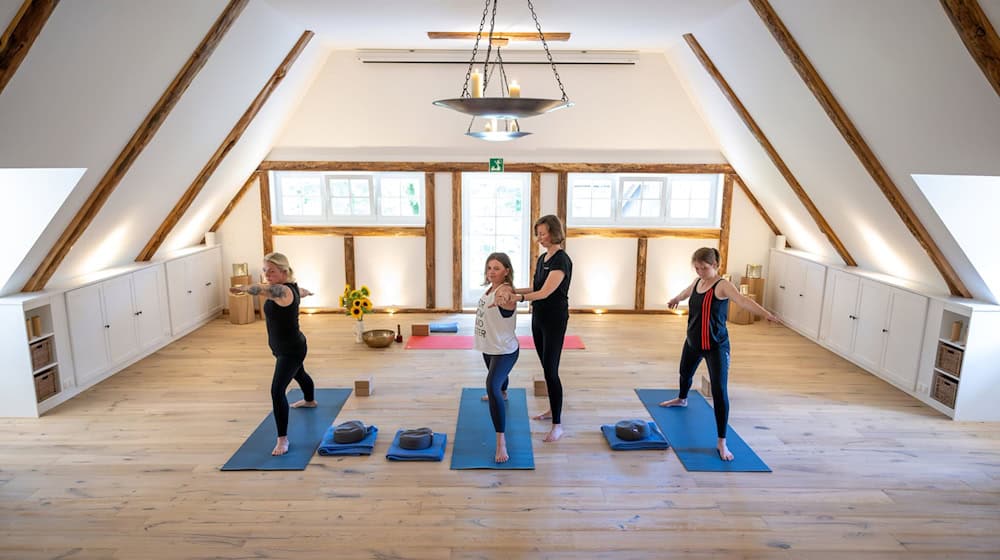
[0,315,1000,560]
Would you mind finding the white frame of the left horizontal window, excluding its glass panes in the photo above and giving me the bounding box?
[270,171,427,226]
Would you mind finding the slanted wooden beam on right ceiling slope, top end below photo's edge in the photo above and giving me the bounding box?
[684,33,858,266]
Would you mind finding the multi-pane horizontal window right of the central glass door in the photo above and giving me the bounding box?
[567,173,721,227]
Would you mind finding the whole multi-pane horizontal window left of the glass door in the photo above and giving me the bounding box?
[273,171,425,225]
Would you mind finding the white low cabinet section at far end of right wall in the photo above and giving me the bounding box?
[767,251,826,338]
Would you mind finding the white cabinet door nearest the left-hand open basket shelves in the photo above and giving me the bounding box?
[66,284,111,386]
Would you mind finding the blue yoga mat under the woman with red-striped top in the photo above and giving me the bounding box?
[635,389,771,472]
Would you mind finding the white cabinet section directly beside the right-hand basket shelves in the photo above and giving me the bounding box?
[819,268,928,392]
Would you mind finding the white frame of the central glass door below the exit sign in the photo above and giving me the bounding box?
[461,172,534,308]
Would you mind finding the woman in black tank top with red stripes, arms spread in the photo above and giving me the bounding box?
[660,247,780,461]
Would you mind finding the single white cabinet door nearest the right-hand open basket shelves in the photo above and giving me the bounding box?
[882,290,928,391]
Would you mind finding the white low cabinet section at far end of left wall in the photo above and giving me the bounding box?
[166,246,222,337]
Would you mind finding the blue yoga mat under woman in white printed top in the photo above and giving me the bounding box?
[451,387,535,470]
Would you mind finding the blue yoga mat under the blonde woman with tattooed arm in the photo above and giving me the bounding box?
[222,389,351,471]
